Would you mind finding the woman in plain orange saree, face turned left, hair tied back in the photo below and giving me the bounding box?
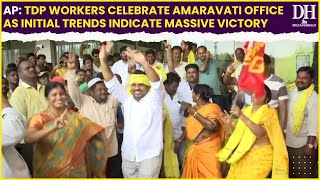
[182,84,224,178]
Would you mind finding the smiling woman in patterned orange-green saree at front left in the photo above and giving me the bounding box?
[25,83,107,178]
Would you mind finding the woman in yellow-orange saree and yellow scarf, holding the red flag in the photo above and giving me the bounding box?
[217,85,288,178]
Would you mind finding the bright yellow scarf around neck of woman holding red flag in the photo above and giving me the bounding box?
[217,105,268,164]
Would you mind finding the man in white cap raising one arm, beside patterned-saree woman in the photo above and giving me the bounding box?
[65,54,121,178]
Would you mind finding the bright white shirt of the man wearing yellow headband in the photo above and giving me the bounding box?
[106,76,164,162]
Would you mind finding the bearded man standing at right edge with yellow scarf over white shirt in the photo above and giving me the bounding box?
[286,66,318,178]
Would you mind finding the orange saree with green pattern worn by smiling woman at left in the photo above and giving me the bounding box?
[28,111,108,178]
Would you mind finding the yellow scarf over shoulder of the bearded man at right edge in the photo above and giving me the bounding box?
[293,84,314,135]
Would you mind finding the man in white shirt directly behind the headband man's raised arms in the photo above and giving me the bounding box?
[111,46,141,86]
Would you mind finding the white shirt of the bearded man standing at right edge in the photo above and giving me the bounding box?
[286,88,318,148]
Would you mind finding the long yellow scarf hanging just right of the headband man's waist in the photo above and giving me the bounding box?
[163,105,180,178]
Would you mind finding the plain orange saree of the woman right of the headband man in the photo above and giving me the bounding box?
[182,103,224,178]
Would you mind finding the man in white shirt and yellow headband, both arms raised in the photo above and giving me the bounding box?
[99,42,164,178]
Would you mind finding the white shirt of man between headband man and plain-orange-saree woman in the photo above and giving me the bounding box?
[164,92,185,140]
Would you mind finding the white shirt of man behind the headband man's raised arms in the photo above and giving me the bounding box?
[111,59,141,87]
